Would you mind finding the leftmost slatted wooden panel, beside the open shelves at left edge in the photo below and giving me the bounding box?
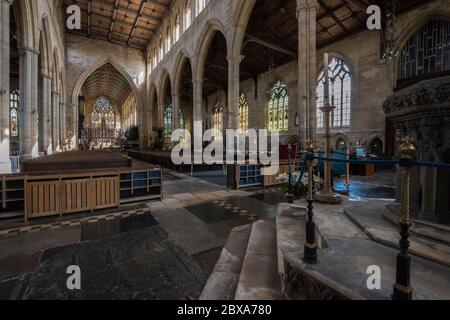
[25,181,61,218]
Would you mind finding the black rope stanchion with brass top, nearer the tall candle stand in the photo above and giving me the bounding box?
[303,142,317,263]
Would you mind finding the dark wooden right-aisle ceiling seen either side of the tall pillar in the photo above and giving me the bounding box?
[237,0,428,84]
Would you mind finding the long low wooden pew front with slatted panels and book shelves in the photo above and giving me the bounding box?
[0,168,162,219]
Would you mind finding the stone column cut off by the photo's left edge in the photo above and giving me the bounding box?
[0,0,12,173]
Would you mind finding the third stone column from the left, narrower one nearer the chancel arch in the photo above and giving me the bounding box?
[39,74,53,155]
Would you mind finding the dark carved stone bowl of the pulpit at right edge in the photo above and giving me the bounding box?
[383,77,450,162]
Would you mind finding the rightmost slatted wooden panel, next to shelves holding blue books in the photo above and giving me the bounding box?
[92,176,120,210]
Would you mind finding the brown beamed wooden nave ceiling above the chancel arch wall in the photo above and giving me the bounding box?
[64,0,172,50]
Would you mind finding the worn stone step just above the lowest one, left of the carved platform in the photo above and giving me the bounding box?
[235,220,284,300]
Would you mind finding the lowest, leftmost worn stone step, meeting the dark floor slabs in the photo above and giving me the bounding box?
[199,224,252,300]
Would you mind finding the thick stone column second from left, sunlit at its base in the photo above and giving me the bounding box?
[19,47,39,160]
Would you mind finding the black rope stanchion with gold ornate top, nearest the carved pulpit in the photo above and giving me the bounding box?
[392,137,417,300]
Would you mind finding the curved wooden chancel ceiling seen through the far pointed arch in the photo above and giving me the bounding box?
[81,63,132,107]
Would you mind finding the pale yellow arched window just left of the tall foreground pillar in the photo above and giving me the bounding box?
[267,80,289,132]
